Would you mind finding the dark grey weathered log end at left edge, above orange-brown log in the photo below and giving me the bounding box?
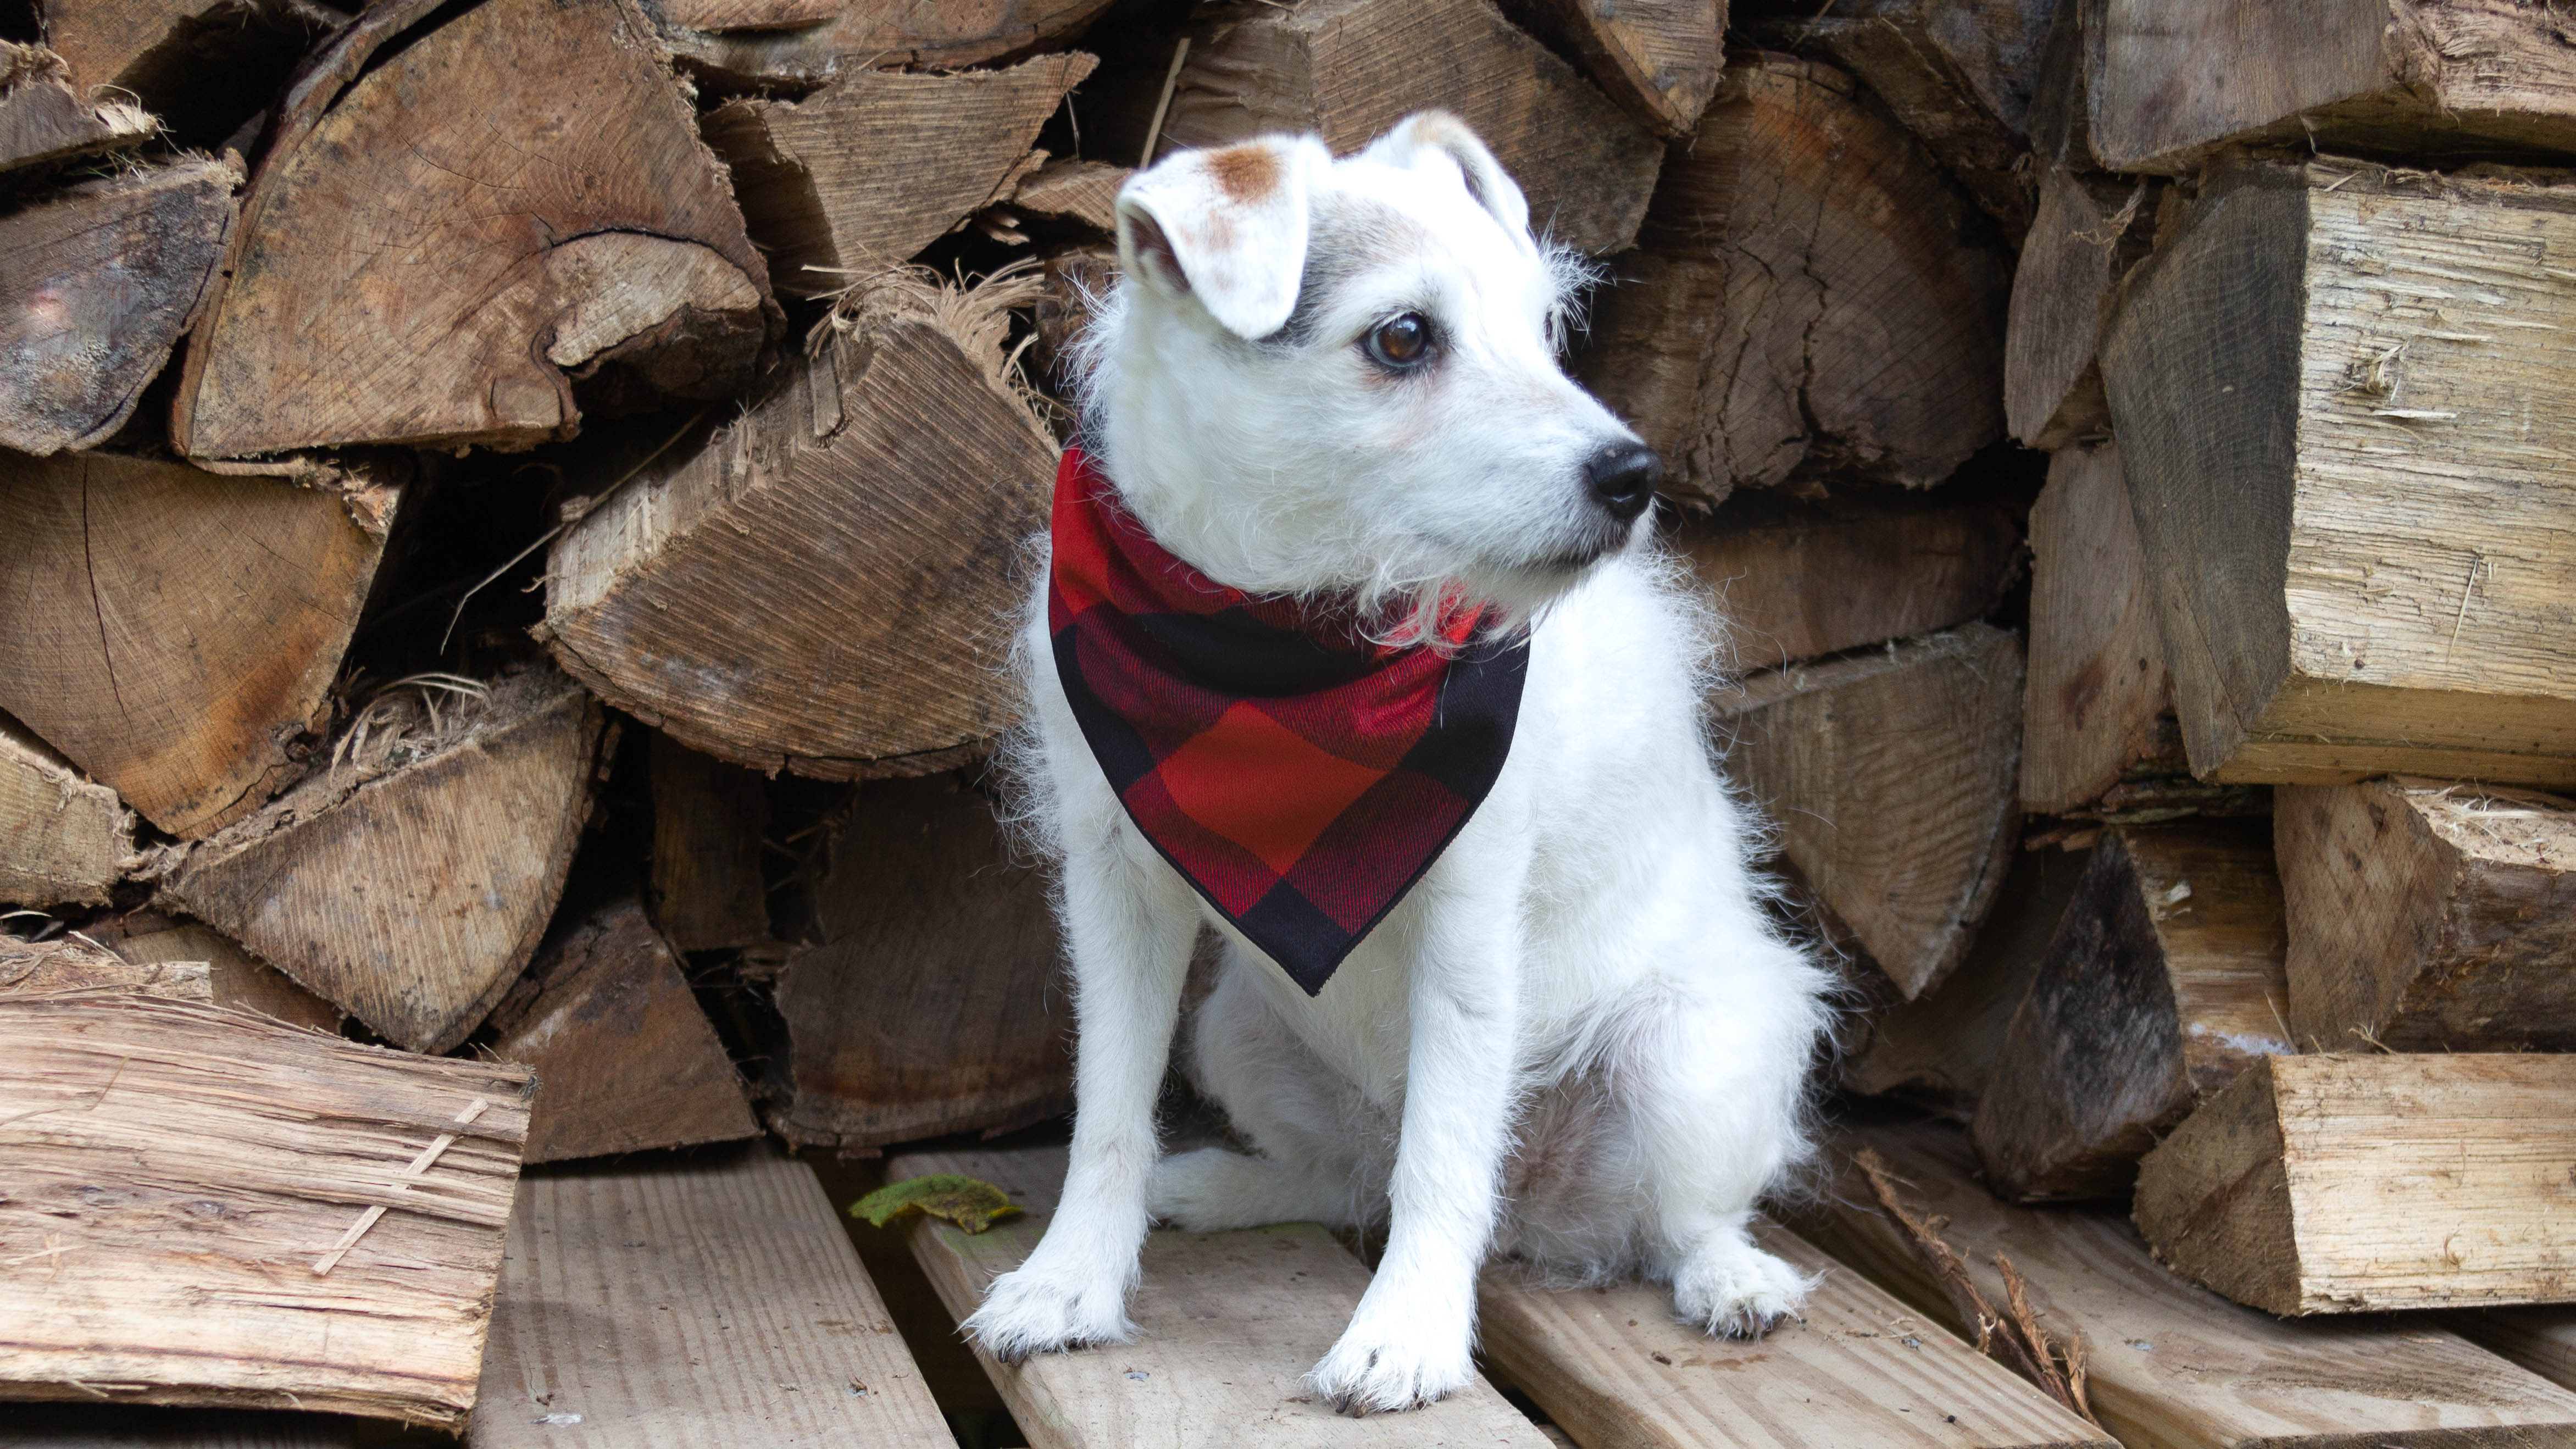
[0,160,242,457]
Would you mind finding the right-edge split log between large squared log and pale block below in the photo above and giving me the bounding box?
[2272,779,2576,1052]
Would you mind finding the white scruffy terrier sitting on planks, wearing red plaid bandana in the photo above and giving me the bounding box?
[969,111,1826,1413]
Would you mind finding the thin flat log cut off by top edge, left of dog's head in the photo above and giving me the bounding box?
[657,0,1108,90]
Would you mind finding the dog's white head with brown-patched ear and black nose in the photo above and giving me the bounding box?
[1085,111,1662,629]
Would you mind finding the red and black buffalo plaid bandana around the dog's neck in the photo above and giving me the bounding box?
[1046,448,1530,995]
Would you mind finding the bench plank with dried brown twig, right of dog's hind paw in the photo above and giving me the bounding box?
[1796,1124,2576,1449]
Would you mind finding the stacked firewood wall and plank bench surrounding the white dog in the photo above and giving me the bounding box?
[15,0,2576,1449]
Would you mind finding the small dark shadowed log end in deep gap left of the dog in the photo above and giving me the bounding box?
[652,735,770,954]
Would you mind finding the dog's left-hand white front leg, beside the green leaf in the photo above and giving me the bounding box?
[963,830,1198,1364]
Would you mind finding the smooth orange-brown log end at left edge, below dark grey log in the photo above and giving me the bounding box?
[0,454,402,838]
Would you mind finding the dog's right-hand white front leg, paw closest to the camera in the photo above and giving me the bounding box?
[1311,861,1523,1413]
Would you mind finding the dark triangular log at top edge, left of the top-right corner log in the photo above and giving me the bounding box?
[1749,0,2058,245]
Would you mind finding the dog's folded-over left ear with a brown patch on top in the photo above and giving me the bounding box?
[1118,137,1332,338]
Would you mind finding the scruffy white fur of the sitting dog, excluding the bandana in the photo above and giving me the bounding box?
[966,113,1826,1413]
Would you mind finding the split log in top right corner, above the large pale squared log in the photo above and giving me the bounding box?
[2084,0,2576,175]
